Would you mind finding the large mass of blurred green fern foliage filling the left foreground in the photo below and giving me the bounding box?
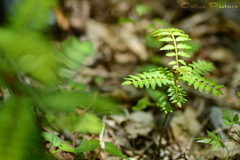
[0,0,120,160]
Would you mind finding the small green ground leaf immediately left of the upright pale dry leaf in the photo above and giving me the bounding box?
[74,139,100,153]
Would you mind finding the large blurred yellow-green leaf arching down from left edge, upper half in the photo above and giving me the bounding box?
[0,28,59,85]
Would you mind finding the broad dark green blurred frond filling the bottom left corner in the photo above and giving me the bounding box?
[0,97,44,160]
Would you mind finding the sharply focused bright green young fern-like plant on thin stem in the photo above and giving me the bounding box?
[122,28,224,152]
